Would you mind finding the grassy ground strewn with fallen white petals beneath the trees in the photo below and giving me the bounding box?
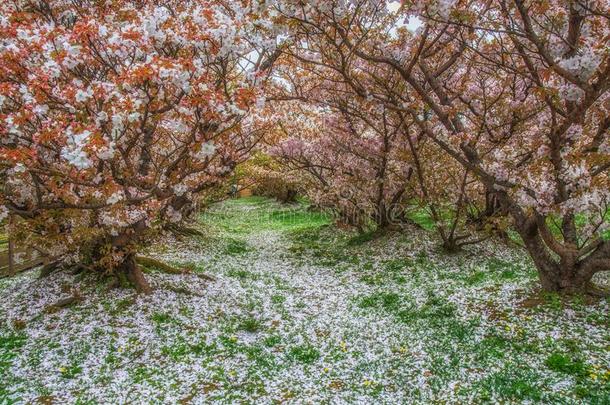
[0,198,610,404]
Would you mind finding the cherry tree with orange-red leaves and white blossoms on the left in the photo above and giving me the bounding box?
[0,0,275,293]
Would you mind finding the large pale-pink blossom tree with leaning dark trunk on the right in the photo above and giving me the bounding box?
[272,0,610,294]
